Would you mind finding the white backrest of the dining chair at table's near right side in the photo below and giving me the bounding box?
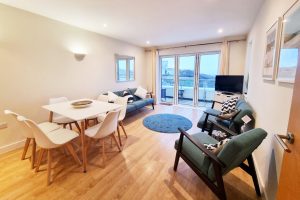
[94,110,120,138]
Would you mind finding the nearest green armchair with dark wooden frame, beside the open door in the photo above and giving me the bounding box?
[174,121,267,199]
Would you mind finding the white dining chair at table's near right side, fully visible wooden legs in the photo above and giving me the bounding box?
[85,110,121,163]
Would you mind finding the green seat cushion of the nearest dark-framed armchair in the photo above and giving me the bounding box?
[175,132,218,175]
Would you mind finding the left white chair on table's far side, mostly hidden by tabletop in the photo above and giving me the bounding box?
[49,97,80,132]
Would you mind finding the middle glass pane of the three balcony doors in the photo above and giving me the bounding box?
[178,55,196,106]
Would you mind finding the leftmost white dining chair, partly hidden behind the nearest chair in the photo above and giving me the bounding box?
[4,110,61,169]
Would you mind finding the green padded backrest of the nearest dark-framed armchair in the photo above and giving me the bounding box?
[208,128,267,180]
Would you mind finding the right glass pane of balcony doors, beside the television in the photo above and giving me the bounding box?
[198,52,220,107]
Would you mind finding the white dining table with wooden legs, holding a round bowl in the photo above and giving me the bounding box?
[42,99,122,172]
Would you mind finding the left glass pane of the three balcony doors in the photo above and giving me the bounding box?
[160,56,175,104]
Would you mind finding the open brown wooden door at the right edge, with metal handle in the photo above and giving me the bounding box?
[277,48,300,200]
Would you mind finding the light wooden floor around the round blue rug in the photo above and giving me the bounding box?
[0,105,257,200]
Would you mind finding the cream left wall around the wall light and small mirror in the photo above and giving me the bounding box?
[0,4,146,152]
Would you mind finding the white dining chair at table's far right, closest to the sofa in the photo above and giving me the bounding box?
[98,96,128,146]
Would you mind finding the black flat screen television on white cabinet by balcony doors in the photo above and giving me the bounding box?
[215,75,244,94]
